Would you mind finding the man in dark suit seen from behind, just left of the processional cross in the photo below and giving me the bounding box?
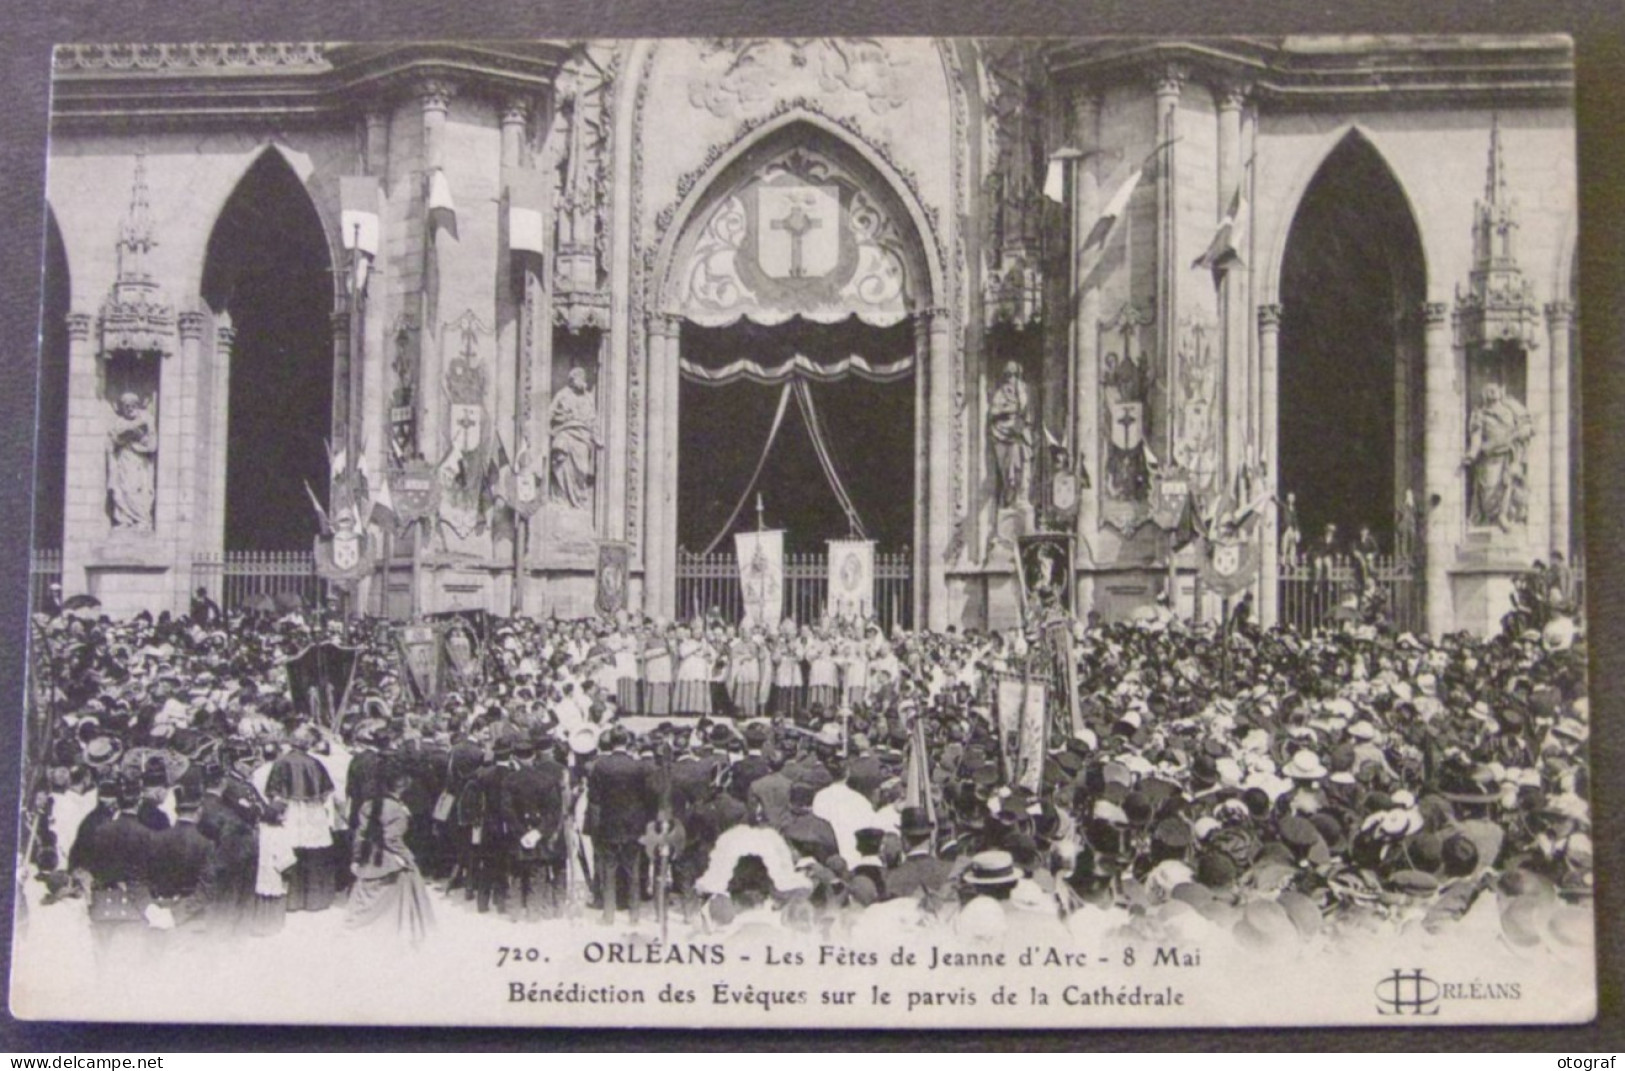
[583,726,657,925]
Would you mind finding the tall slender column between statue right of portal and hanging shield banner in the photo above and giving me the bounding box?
[1069,89,1105,557]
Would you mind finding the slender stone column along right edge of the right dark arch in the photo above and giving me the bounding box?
[1419,301,1466,635]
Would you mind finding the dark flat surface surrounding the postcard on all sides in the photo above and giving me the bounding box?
[0,0,1625,1066]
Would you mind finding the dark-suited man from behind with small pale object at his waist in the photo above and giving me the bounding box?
[502,739,566,920]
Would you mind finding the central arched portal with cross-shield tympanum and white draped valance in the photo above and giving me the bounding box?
[650,122,946,624]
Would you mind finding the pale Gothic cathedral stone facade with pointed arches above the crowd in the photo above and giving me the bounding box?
[41,37,1580,632]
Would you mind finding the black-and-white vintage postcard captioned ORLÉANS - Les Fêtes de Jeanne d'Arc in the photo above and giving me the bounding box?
[11,36,1597,1027]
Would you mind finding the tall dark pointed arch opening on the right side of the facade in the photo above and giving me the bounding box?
[1277,132,1427,624]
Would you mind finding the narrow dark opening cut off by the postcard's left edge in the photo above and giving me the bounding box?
[34,211,72,549]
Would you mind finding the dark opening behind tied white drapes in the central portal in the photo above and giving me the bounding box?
[678,319,915,554]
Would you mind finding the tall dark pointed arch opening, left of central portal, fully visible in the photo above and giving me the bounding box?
[203,150,333,553]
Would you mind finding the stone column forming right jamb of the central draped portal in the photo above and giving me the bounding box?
[915,307,959,629]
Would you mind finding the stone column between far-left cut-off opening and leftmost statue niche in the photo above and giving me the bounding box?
[62,312,107,596]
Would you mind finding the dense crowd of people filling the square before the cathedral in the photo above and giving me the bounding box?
[24,585,1593,956]
